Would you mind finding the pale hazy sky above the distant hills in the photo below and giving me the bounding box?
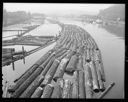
[3,3,113,15]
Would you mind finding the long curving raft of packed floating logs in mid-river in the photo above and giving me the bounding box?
[5,23,109,98]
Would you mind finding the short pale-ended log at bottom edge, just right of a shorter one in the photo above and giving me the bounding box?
[41,84,54,98]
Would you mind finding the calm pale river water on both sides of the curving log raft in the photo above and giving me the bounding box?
[2,19,125,98]
